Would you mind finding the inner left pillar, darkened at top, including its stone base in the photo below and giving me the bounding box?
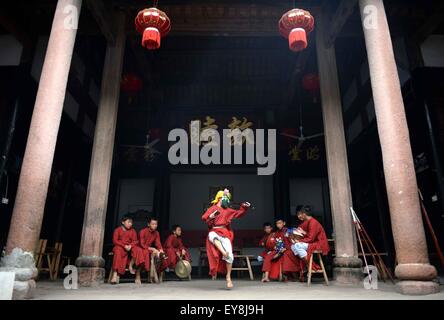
[76,12,126,286]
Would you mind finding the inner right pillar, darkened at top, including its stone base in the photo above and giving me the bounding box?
[316,13,362,284]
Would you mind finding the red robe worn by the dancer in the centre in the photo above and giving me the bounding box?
[202,205,248,276]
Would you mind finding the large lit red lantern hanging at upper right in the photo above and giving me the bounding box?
[279,9,314,52]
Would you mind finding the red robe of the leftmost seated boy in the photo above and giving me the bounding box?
[113,226,139,274]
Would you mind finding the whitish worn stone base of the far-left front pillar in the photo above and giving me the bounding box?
[0,248,38,300]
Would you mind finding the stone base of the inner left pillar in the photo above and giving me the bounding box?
[76,256,105,287]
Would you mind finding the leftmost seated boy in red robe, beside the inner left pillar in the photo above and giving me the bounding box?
[111,216,139,284]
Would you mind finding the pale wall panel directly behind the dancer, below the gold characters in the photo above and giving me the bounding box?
[169,173,274,230]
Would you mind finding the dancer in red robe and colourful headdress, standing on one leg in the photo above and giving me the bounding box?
[202,189,250,289]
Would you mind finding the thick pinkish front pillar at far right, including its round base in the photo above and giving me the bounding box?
[359,0,439,294]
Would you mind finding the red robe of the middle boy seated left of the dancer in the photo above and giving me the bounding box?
[136,227,166,272]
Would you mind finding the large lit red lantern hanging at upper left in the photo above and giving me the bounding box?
[135,8,171,50]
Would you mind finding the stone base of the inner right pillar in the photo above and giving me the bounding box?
[333,257,363,285]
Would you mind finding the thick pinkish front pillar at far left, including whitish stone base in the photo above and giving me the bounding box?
[1,0,82,299]
